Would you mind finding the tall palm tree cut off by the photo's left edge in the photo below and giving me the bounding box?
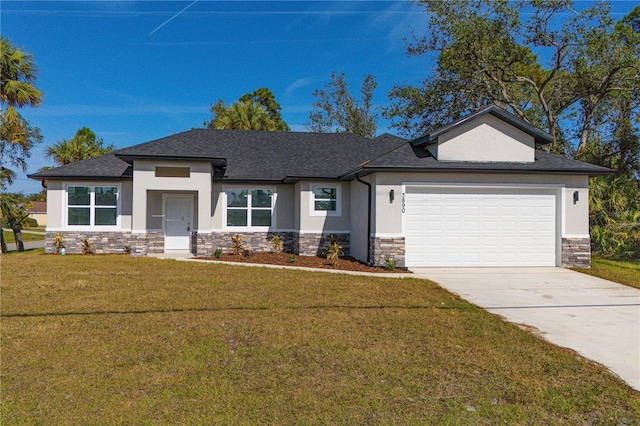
[0,36,43,189]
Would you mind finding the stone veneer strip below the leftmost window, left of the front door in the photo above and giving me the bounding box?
[44,231,164,256]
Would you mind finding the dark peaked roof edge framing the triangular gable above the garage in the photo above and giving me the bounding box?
[411,105,553,146]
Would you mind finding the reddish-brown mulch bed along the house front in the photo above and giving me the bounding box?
[203,253,410,274]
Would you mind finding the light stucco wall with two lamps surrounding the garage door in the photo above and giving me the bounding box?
[372,173,589,237]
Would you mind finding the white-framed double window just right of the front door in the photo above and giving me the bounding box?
[225,189,273,227]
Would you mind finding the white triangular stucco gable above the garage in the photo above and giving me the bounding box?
[436,114,535,162]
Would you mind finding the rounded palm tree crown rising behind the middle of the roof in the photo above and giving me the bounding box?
[210,99,281,131]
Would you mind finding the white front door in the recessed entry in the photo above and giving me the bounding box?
[164,195,193,251]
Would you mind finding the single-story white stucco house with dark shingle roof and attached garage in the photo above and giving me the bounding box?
[31,106,610,267]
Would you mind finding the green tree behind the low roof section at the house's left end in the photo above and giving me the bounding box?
[47,127,115,165]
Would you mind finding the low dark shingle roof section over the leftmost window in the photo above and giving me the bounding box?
[29,153,133,179]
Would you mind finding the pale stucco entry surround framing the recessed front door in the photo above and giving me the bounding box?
[132,160,212,232]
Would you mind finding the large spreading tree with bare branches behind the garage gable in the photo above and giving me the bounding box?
[385,0,640,152]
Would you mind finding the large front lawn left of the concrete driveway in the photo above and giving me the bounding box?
[0,253,640,425]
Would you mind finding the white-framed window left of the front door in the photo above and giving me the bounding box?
[67,186,118,226]
